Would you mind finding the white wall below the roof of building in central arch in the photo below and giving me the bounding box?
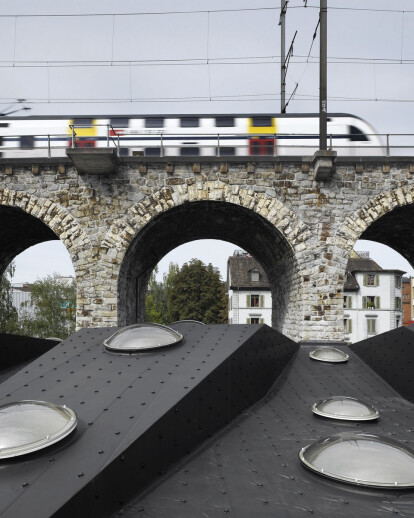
[229,290,272,326]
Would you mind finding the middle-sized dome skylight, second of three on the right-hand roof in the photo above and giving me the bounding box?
[312,396,379,421]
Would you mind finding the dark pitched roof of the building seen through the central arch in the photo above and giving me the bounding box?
[227,255,270,290]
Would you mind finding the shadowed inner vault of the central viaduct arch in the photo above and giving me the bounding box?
[118,201,300,337]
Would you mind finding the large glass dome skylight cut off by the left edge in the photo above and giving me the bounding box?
[0,401,77,459]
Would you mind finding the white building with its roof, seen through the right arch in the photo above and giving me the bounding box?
[344,252,405,343]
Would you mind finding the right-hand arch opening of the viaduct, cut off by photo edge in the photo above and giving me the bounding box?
[343,203,414,343]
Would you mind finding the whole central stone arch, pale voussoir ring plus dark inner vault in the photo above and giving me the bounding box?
[103,181,309,337]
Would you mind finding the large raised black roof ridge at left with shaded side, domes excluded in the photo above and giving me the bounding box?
[0,324,297,518]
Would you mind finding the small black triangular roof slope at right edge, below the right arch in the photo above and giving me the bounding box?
[350,325,414,403]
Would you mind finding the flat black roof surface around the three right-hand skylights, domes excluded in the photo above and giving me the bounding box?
[116,345,414,518]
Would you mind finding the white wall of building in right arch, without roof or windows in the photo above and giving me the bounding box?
[344,270,403,343]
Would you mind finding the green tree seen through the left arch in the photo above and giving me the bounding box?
[19,274,76,338]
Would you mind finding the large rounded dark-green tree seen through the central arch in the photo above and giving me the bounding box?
[168,259,228,324]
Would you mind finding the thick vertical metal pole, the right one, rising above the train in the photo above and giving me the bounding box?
[319,0,328,151]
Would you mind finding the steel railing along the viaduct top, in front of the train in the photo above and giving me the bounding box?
[0,124,414,157]
